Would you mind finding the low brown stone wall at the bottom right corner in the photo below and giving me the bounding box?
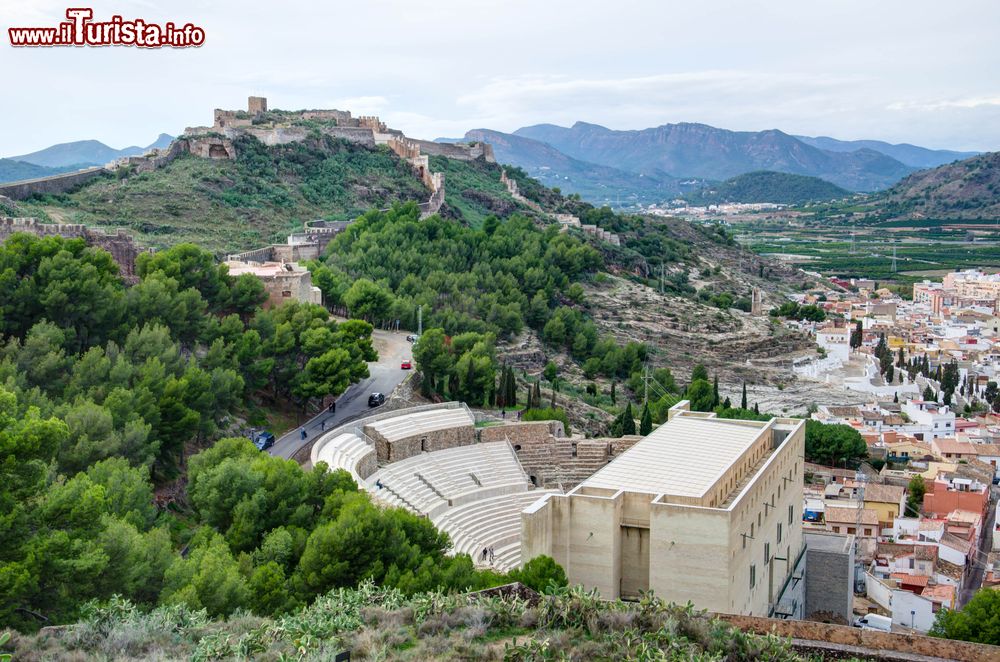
[718,614,1000,662]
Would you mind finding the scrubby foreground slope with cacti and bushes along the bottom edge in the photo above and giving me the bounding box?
[3,583,814,662]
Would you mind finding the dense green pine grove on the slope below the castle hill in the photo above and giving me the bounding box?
[311,204,601,336]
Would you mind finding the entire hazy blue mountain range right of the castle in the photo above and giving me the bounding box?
[442,122,975,203]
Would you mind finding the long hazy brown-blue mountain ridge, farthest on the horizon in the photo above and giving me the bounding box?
[514,122,914,191]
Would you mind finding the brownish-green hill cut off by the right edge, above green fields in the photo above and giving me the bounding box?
[877,152,1000,219]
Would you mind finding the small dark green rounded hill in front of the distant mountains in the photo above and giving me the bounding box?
[687,170,852,205]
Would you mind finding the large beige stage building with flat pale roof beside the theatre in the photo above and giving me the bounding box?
[521,401,805,615]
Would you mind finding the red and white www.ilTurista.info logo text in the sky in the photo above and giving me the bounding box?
[7,7,205,48]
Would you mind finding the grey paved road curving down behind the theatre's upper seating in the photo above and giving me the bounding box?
[269,330,413,458]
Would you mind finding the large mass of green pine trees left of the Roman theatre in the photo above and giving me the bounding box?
[0,235,375,627]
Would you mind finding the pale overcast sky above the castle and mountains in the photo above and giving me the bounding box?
[0,0,1000,156]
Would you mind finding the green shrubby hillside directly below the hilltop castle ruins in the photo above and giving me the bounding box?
[12,136,428,255]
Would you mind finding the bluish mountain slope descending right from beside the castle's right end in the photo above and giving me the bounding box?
[452,129,703,204]
